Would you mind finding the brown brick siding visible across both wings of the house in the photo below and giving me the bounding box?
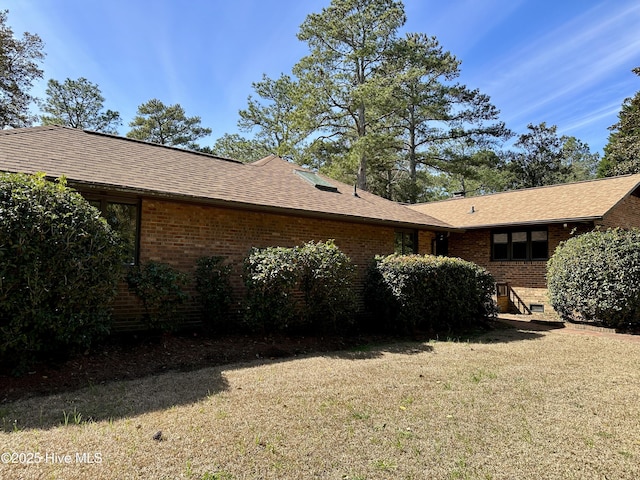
[114,196,640,328]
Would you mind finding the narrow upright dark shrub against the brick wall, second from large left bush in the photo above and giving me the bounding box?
[194,256,236,331]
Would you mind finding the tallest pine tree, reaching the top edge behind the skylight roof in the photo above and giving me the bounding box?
[293,0,406,190]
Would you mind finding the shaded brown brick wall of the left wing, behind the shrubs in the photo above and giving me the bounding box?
[114,199,434,328]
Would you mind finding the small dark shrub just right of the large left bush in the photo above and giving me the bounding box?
[127,262,188,332]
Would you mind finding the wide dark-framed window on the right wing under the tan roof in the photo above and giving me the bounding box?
[491,229,549,261]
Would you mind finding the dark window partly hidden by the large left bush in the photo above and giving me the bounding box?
[88,198,139,265]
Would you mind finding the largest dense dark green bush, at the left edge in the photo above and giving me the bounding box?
[0,174,123,372]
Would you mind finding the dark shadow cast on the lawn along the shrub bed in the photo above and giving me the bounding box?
[0,320,553,432]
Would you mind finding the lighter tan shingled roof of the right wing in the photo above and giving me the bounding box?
[410,174,640,229]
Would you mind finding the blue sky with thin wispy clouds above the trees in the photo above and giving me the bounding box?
[1,0,640,153]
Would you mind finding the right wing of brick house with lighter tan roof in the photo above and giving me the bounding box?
[410,175,640,314]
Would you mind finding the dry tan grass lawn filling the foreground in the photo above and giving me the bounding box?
[0,320,640,480]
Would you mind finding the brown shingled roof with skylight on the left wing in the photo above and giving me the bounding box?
[0,126,452,230]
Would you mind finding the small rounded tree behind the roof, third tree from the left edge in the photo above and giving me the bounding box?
[127,98,211,150]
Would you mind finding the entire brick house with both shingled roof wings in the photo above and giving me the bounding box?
[0,126,640,329]
